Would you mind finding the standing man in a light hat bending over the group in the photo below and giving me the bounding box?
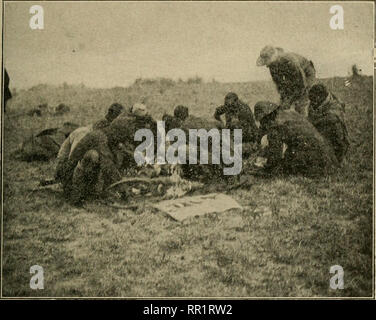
[256,46,316,116]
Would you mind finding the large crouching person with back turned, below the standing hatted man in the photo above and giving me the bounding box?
[255,101,338,176]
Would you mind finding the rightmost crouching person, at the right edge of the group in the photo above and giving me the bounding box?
[308,84,350,163]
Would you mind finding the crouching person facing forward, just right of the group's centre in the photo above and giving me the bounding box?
[214,92,258,142]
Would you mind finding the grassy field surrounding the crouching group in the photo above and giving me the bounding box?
[2,77,373,297]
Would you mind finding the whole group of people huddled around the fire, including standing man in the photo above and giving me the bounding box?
[55,47,349,208]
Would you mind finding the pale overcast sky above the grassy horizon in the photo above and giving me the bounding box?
[4,2,374,88]
